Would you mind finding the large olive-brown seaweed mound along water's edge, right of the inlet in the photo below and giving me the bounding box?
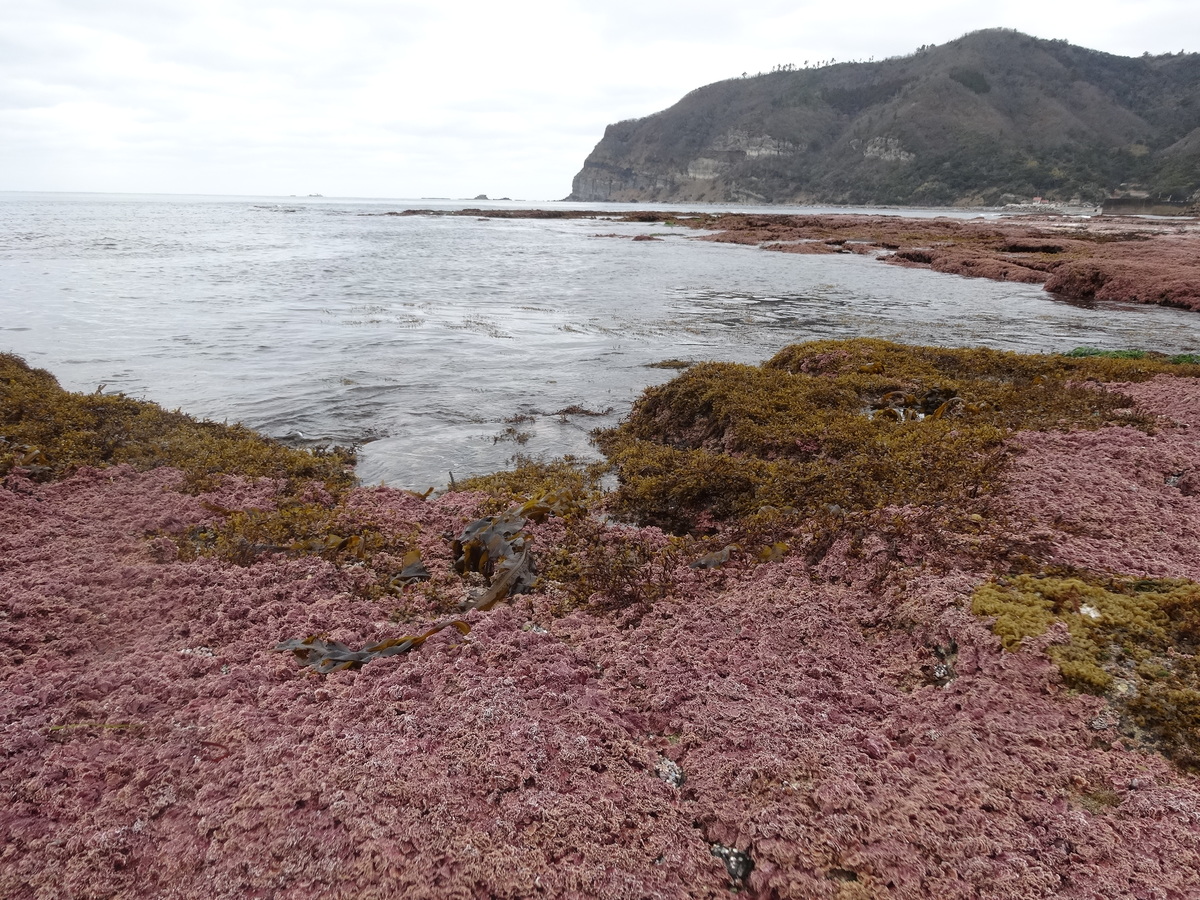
[596,340,1200,532]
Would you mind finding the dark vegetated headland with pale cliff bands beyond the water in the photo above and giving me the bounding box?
[569,29,1200,205]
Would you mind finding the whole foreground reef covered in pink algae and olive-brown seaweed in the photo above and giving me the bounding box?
[0,341,1200,900]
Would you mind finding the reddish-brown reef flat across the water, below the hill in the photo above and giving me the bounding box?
[381,208,1200,311]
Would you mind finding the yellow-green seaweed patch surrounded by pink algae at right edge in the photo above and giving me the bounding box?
[971,575,1200,770]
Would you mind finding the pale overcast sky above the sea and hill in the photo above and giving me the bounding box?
[0,0,1200,200]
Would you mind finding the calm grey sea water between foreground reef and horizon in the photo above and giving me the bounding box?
[0,193,1200,490]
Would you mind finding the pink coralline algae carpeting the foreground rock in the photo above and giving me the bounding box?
[0,378,1200,900]
